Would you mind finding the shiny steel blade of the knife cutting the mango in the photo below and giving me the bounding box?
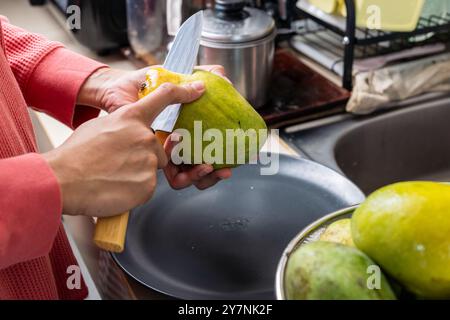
[152,11,203,132]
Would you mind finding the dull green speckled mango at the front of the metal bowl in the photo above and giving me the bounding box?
[284,241,396,300]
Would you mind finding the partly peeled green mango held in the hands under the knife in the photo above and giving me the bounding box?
[139,67,267,169]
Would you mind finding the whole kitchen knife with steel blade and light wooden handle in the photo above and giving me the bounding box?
[94,11,203,252]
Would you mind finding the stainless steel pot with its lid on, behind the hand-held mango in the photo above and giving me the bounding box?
[199,0,276,108]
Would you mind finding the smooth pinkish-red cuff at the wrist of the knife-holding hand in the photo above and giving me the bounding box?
[0,153,62,269]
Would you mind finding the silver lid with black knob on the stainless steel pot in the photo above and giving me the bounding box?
[202,0,275,43]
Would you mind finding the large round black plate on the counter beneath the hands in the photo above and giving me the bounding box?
[113,156,364,299]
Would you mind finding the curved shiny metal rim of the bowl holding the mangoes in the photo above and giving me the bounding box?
[275,206,358,300]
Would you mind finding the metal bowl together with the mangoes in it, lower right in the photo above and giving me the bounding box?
[275,181,450,300]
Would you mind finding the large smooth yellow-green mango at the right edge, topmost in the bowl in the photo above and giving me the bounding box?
[352,182,450,299]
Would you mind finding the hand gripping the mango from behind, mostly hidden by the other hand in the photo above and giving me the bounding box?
[78,65,231,189]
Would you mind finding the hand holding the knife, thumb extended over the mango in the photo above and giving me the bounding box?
[43,83,204,217]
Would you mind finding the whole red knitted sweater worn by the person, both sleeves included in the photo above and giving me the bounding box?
[0,17,103,300]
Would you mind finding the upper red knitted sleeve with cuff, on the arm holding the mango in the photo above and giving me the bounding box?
[1,18,105,128]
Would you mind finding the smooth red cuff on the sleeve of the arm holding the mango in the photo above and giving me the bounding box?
[26,48,106,128]
